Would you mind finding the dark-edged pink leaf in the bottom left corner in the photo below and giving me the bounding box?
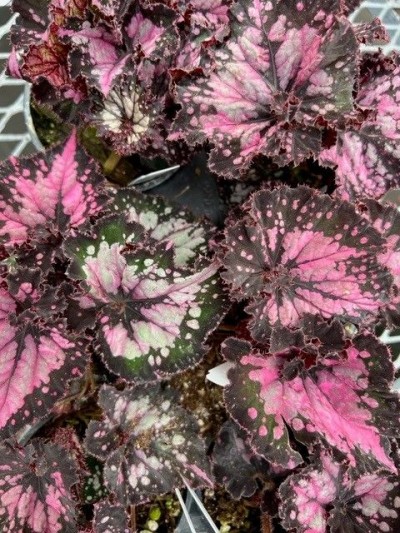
[0,441,77,533]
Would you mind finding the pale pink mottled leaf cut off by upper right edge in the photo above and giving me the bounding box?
[319,56,400,200]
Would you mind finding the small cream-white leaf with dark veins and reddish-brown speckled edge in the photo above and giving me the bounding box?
[94,76,165,155]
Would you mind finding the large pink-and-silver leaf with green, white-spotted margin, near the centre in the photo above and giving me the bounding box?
[66,216,227,380]
